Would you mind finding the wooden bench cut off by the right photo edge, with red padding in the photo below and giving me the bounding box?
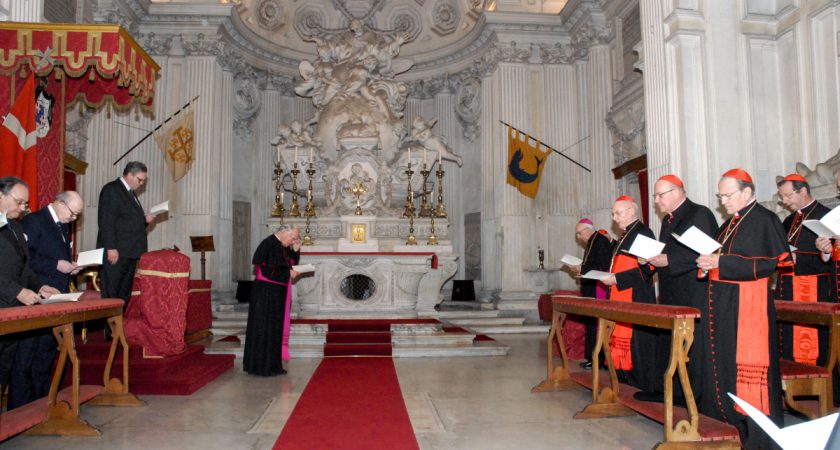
[776,300,840,419]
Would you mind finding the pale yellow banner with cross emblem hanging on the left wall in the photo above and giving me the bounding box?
[155,105,195,181]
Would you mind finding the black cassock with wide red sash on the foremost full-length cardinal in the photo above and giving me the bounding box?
[694,202,790,448]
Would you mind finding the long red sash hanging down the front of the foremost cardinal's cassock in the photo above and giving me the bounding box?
[709,269,770,415]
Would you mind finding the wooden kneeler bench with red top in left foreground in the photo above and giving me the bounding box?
[0,297,144,441]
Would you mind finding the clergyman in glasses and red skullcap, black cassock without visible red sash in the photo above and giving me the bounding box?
[636,175,718,402]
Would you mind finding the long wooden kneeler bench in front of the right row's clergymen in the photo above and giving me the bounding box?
[532,295,740,449]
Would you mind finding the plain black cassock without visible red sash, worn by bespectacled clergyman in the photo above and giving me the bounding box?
[656,199,718,401]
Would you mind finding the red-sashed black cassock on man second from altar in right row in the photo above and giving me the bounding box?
[610,220,662,391]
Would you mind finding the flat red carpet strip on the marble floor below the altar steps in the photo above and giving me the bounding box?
[274,358,419,450]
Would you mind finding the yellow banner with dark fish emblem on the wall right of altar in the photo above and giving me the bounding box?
[507,127,551,198]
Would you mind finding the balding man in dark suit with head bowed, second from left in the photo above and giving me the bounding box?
[9,191,85,410]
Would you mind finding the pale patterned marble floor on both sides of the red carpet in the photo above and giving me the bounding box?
[0,335,662,450]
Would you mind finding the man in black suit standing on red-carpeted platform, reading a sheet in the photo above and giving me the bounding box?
[96,161,154,303]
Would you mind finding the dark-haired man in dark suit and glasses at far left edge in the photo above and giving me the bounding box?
[0,177,58,400]
